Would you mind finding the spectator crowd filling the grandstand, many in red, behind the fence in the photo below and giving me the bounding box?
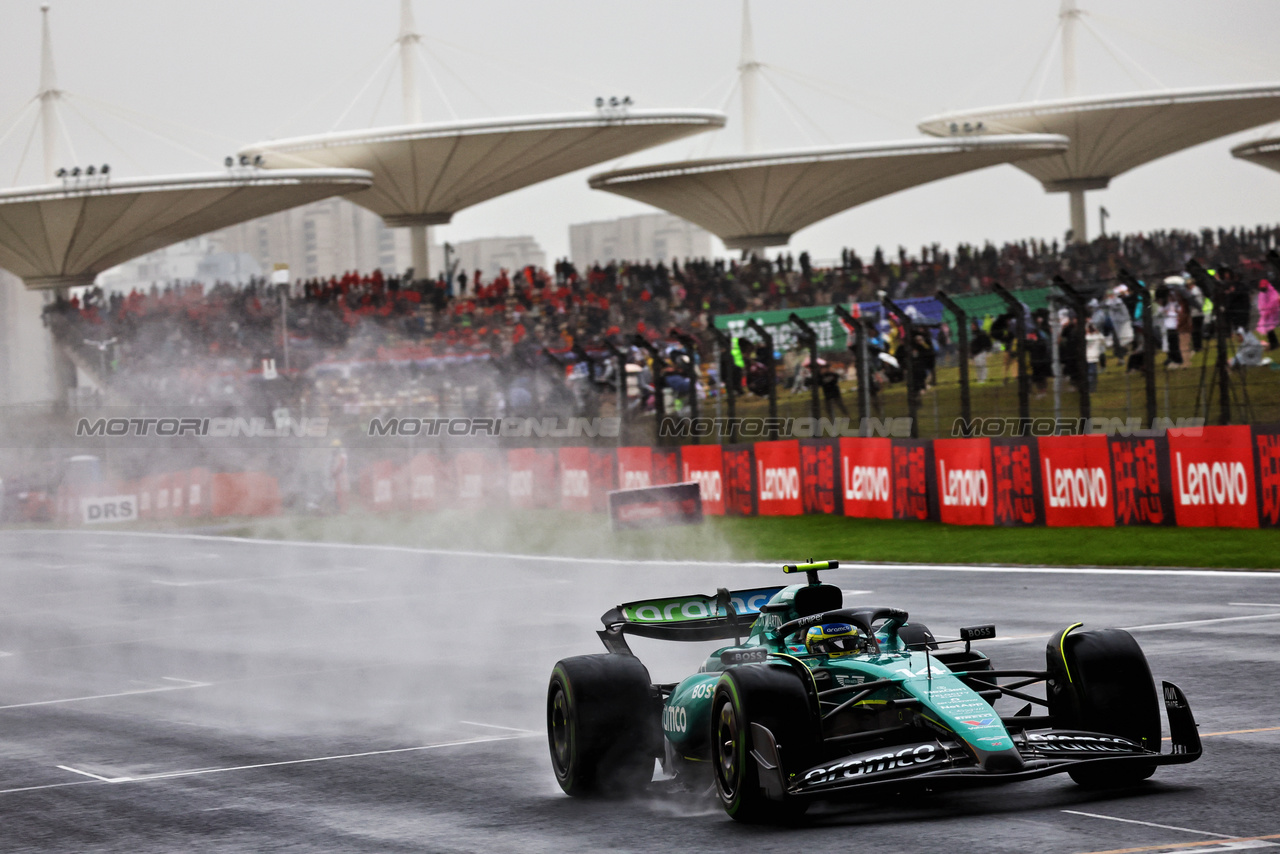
[45,227,1280,414]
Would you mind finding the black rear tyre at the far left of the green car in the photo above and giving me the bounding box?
[547,654,662,796]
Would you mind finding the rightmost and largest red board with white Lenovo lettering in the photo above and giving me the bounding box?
[1169,425,1258,528]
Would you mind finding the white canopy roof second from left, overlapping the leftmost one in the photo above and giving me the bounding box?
[243,110,724,225]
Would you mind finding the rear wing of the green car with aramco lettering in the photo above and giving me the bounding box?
[596,588,782,654]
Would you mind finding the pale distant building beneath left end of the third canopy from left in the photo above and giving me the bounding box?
[568,214,712,268]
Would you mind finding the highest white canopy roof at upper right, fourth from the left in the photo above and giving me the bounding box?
[919,83,1280,192]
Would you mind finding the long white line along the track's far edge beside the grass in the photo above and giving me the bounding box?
[8,529,1280,580]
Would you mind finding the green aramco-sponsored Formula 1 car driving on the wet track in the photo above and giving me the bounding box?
[547,561,1201,822]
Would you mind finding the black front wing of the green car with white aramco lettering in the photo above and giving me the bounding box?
[751,682,1202,800]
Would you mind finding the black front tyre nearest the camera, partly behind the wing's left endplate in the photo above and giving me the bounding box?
[710,665,822,823]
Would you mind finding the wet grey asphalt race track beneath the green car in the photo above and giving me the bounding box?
[0,533,1280,854]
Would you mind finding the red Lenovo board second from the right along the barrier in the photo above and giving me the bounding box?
[1036,435,1116,528]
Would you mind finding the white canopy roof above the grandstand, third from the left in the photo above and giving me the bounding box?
[590,134,1068,248]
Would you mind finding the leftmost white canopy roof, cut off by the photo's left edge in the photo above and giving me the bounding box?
[0,169,372,288]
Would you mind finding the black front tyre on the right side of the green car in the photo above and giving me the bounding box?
[1046,626,1160,787]
